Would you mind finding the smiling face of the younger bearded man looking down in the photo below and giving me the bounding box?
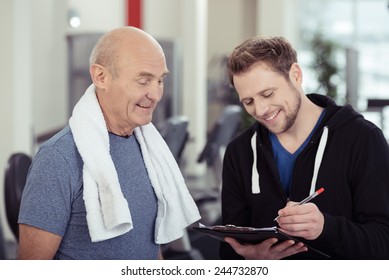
[233,62,301,134]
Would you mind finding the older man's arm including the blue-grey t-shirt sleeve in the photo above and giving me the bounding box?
[18,149,72,259]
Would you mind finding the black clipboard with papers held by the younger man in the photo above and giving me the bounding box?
[192,224,330,259]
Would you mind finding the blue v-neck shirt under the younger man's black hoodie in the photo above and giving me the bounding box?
[270,109,325,197]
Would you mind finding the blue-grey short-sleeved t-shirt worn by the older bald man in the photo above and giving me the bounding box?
[19,126,159,260]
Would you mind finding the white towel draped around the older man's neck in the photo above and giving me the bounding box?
[69,84,200,244]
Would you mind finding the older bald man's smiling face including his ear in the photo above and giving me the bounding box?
[92,28,168,135]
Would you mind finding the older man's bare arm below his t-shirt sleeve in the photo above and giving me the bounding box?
[17,224,62,260]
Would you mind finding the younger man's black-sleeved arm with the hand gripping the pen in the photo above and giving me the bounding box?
[278,129,389,259]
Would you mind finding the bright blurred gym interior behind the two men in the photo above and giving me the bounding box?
[0,0,389,258]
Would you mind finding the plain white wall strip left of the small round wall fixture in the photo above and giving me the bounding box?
[31,0,68,137]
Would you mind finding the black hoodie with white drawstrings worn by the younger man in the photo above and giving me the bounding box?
[220,94,389,259]
